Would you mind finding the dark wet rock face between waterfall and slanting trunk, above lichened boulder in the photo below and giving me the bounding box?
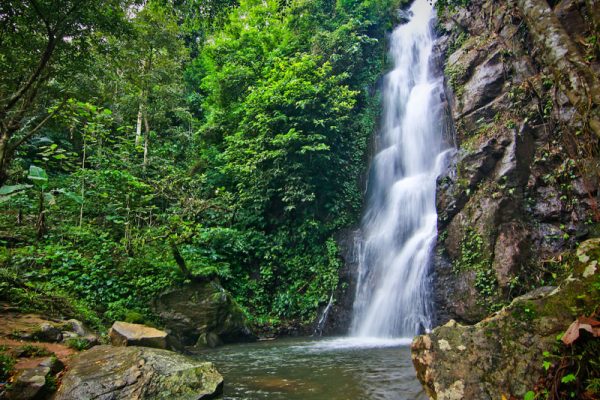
[433,0,599,325]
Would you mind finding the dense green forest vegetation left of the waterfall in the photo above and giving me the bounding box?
[0,0,399,325]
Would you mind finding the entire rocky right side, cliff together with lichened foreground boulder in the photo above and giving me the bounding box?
[413,0,600,399]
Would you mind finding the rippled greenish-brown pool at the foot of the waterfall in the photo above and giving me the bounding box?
[197,338,427,400]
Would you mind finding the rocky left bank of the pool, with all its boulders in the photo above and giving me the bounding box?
[0,282,257,400]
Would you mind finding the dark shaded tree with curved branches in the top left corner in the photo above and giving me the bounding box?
[0,0,127,186]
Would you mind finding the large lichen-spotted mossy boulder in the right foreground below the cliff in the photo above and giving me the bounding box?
[412,239,600,400]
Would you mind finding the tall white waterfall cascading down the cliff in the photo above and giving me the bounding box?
[351,0,446,338]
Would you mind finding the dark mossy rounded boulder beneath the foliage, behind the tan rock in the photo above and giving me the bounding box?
[154,282,256,347]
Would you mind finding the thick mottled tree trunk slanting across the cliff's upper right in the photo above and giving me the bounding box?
[517,0,600,137]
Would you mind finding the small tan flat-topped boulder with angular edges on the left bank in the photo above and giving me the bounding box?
[108,321,167,349]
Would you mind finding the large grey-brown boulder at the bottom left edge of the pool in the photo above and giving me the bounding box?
[55,346,223,400]
